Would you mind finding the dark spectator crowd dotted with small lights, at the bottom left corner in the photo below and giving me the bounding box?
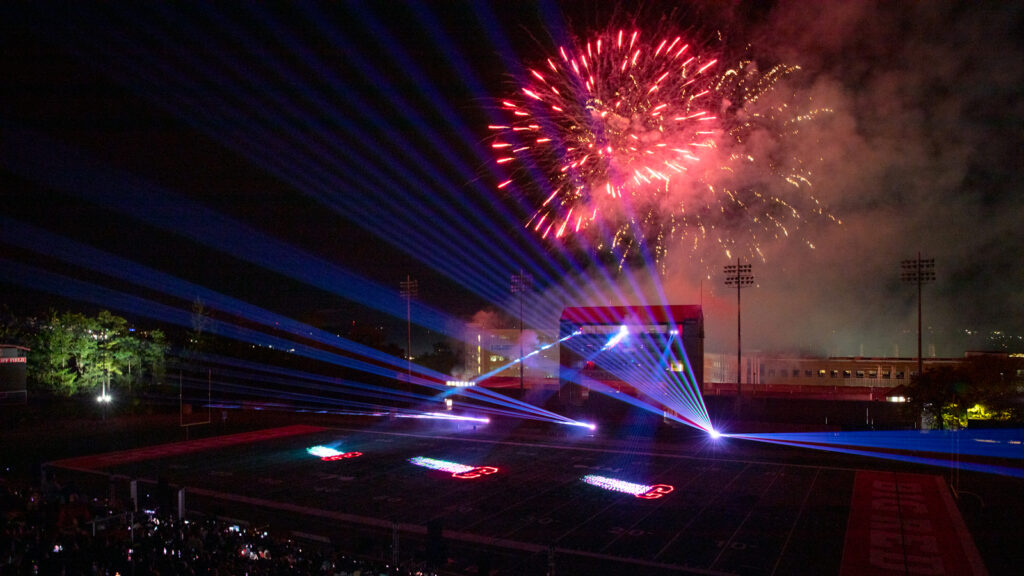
[0,471,430,576]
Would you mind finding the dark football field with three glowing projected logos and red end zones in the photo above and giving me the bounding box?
[50,425,984,575]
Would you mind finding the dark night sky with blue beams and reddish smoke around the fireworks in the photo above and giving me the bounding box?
[0,1,1024,357]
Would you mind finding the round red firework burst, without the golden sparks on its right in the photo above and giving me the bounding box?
[490,31,720,238]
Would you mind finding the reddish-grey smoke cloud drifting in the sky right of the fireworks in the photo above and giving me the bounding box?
[651,2,1024,356]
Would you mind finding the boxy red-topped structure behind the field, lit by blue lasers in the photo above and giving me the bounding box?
[558,305,705,406]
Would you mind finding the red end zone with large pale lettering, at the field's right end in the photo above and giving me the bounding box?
[840,470,986,576]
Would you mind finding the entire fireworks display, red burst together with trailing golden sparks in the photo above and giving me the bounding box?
[490,26,823,266]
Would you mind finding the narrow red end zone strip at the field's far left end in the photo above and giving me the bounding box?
[50,424,325,469]
